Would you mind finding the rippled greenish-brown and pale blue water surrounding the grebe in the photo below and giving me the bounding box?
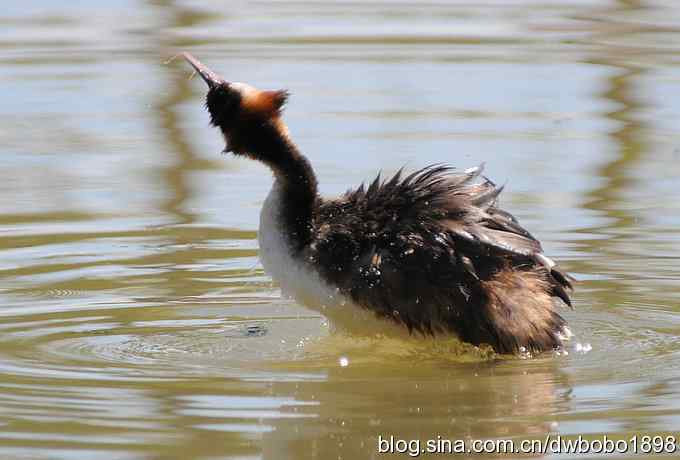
[0,0,680,460]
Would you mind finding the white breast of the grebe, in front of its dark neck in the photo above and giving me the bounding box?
[258,181,346,308]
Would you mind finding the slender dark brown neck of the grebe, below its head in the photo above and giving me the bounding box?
[251,120,319,252]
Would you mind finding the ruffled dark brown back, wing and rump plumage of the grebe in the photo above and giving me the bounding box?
[307,165,571,352]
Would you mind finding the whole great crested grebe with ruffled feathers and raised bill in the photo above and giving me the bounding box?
[183,53,572,353]
